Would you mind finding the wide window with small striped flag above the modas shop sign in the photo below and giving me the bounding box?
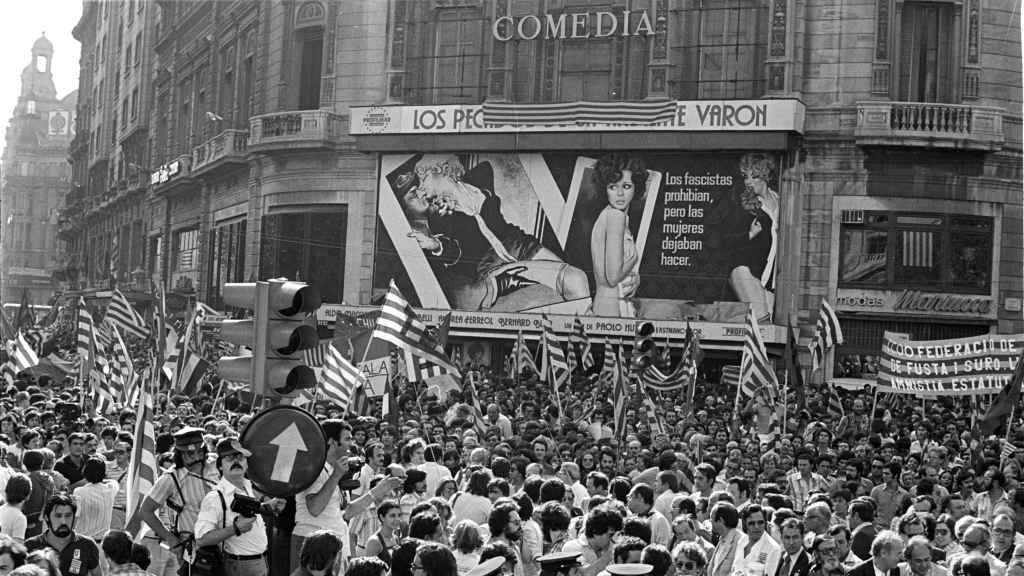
[839,210,993,294]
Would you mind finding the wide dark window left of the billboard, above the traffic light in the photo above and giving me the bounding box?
[259,206,348,303]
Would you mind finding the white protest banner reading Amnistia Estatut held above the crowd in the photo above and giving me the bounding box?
[878,334,1024,396]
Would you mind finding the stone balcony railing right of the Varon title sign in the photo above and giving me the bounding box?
[856,101,1004,151]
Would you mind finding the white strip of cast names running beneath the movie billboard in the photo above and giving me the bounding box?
[317,304,785,342]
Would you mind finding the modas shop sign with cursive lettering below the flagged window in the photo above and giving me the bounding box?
[836,288,996,318]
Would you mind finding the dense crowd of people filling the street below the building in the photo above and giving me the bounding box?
[0,338,1024,576]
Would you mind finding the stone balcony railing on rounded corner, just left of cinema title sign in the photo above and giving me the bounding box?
[249,110,348,149]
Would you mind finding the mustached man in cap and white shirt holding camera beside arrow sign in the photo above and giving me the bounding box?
[196,438,276,576]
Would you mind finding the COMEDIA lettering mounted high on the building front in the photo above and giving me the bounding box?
[490,9,654,42]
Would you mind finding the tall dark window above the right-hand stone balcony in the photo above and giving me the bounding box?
[898,2,957,102]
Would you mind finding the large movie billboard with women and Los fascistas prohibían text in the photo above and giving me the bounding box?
[374,152,781,322]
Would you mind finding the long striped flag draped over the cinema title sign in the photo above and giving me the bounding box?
[483,99,676,126]
